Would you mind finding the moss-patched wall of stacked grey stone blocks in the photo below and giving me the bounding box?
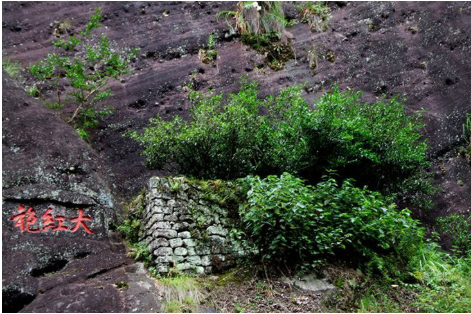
[140,177,243,274]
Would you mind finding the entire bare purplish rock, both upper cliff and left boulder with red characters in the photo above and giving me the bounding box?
[2,1,471,312]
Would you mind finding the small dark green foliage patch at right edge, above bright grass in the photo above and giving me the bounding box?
[437,214,471,257]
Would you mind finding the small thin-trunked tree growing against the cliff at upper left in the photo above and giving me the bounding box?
[29,8,137,139]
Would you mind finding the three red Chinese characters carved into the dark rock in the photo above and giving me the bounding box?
[10,205,94,234]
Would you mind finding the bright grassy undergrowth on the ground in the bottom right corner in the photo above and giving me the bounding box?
[327,242,471,313]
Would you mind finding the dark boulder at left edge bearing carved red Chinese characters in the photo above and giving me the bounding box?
[2,73,159,312]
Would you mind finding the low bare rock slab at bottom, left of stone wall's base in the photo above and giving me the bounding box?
[21,260,162,313]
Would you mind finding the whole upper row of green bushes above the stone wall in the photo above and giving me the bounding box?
[131,78,428,195]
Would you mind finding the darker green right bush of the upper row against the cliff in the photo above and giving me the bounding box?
[309,87,429,189]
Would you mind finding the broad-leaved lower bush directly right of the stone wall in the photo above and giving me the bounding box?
[239,173,423,263]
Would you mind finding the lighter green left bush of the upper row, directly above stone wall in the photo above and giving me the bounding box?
[131,79,311,179]
